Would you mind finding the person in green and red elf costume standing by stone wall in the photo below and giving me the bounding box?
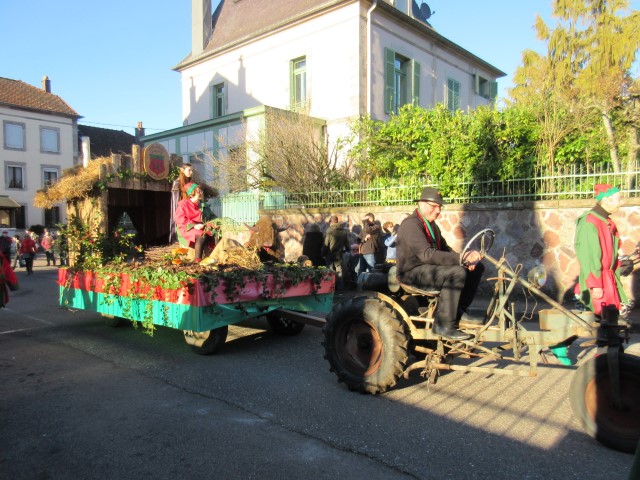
[575,184,633,316]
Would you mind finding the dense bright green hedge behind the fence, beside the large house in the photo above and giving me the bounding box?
[350,105,539,198]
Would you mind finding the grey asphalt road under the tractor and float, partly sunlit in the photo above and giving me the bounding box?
[0,260,633,480]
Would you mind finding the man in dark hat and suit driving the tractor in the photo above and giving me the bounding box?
[396,187,484,340]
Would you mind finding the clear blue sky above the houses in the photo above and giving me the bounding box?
[0,0,640,133]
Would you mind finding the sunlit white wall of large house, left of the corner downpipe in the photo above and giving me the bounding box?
[182,4,361,139]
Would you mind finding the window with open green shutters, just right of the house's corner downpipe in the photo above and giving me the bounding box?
[384,48,420,114]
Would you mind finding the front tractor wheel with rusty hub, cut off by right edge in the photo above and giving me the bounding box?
[570,353,640,453]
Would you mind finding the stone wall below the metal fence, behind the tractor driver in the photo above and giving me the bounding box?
[260,198,640,304]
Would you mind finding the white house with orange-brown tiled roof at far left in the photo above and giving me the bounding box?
[0,77,80,229]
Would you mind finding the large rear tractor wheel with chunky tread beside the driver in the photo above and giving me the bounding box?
[323,297,409,394]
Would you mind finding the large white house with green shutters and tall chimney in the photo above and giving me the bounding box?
[143,0,505,191]
